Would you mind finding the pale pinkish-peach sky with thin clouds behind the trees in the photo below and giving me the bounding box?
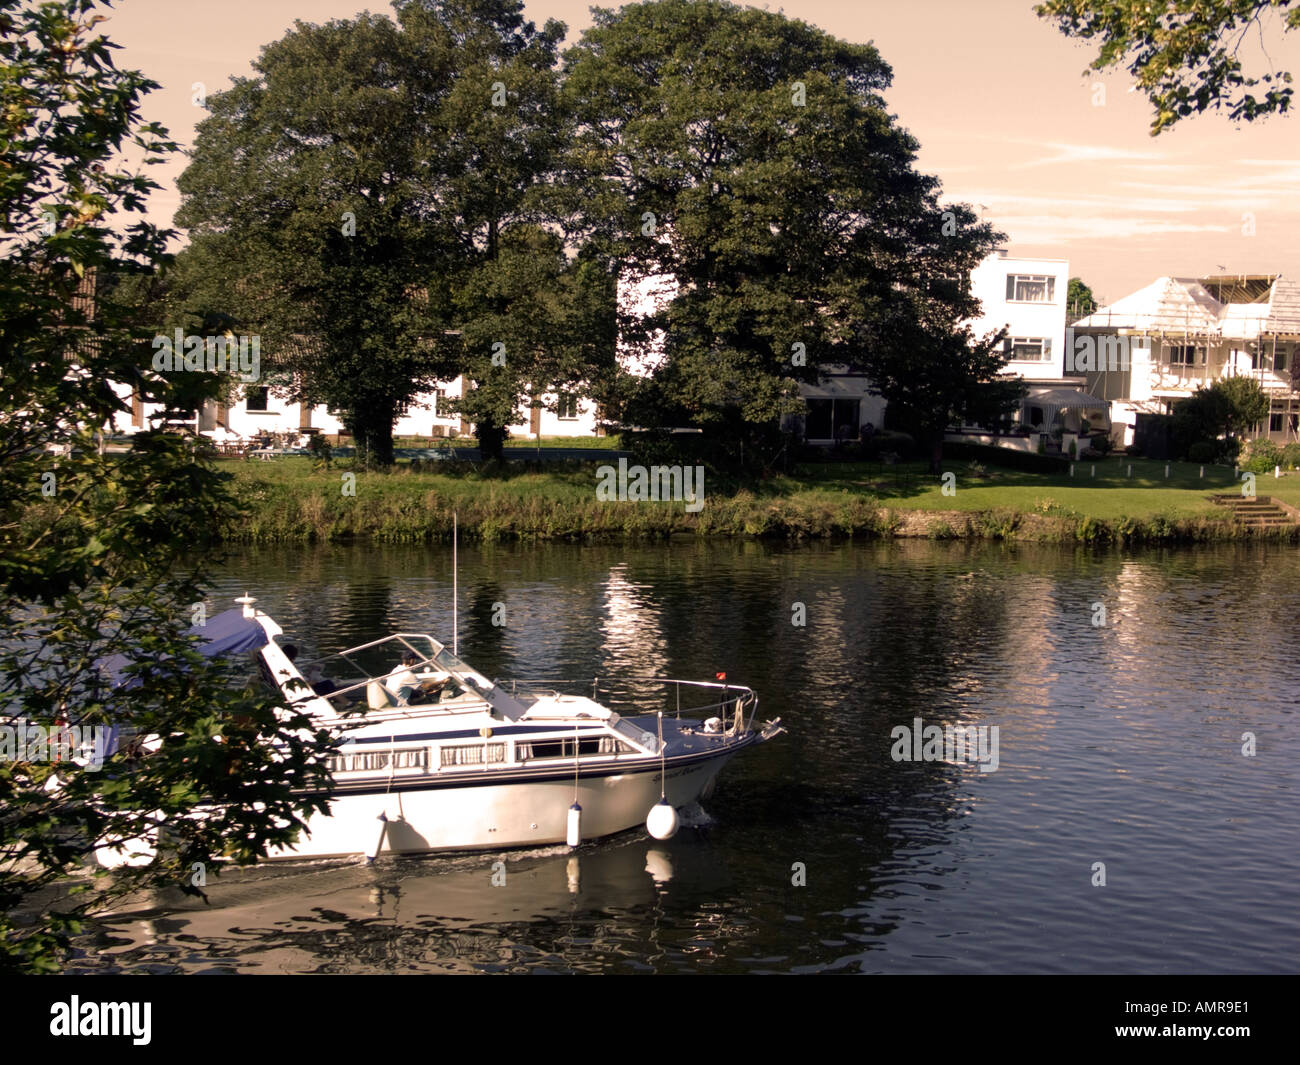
[100,0,1300,308]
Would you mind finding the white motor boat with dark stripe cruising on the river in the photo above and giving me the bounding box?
[191,596,784,858]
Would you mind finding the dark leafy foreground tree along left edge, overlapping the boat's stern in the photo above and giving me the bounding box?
[0,0,329,970]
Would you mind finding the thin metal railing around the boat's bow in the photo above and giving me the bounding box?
[497,676,758,732]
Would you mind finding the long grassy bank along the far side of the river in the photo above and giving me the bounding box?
[210,458,1300,544]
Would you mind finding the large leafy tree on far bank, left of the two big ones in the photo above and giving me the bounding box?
[177,0,595,464]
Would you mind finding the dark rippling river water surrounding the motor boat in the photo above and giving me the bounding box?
[78,542,1300,973]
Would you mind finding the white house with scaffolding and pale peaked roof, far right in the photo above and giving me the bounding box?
[1070,274,1300,445]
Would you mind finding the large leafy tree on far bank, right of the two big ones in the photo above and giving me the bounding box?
[566,0,997,470]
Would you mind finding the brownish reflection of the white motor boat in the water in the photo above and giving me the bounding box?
[86,835,758,973]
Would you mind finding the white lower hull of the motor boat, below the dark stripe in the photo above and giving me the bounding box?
[270,750,735,860]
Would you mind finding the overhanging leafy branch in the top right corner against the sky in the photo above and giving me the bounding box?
[1035,0,1300,137]
